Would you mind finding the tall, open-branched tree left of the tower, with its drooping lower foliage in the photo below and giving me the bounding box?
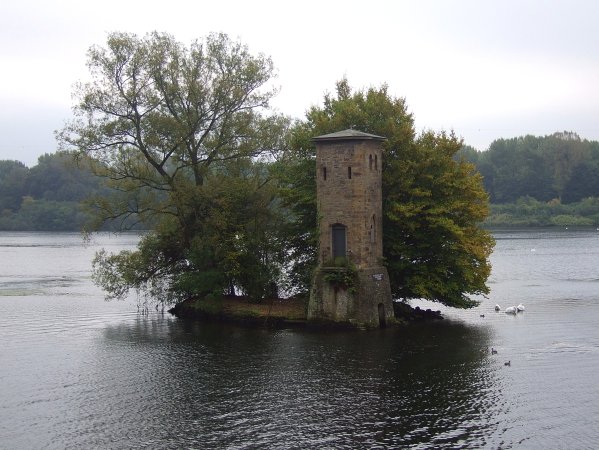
[59,33,287,301]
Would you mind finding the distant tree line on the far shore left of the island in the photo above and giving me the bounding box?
[0,152,100,231]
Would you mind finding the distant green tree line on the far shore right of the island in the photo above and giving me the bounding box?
[456,131,599,226]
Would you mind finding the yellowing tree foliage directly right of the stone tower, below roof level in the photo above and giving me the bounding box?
[383,131,494,308]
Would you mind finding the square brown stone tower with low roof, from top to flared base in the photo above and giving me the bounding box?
[308,130,394,327]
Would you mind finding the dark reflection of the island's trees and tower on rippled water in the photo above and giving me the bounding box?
[65,318,501,448]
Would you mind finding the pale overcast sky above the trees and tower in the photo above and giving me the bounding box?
[0,0,599,166]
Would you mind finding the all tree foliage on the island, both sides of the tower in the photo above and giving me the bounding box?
[59,33,492,307]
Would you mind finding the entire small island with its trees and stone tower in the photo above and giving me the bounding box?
[58,32,494,320]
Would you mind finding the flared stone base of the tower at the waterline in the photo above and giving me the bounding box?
[307,266,395,328]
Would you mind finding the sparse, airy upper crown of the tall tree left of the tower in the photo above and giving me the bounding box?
[59,33,284,228]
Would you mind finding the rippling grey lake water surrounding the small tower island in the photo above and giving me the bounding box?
[0,229,599,449]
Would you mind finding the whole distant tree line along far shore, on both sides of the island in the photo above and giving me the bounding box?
[0,132,599,231]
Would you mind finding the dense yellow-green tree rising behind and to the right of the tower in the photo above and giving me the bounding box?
[283,79,493,308]
